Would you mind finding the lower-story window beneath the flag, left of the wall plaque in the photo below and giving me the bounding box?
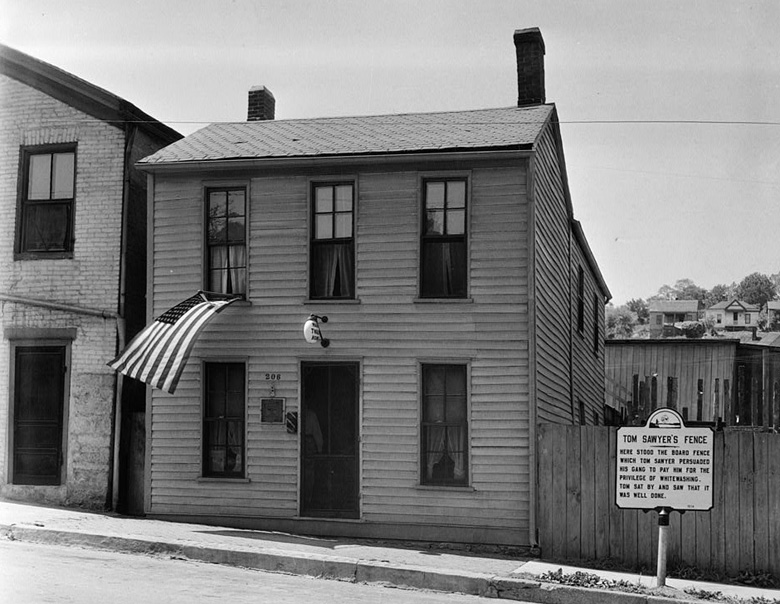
[203,363,246,478]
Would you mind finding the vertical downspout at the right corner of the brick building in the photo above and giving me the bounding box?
[109,123,137,511]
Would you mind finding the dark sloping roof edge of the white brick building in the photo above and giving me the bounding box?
[0,44,181,142]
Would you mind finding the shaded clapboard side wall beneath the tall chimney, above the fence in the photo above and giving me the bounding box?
[534,128,572,423]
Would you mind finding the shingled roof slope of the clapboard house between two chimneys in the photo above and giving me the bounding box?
[139,105,554,168]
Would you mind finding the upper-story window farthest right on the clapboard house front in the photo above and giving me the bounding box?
[420,178,467,298]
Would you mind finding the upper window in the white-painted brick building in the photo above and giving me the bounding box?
[17,145,76,257]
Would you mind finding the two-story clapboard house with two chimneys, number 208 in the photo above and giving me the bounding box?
[134,28,610,545]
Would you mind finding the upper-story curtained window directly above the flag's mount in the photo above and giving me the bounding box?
[206,187,246,295]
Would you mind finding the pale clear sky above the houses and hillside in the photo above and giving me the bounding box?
[0,0,780,304]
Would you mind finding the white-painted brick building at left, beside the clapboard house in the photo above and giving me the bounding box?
[0,45,181,512]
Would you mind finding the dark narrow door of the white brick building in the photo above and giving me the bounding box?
[13,346,65,485]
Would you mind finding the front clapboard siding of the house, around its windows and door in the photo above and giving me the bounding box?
[149,161,531,542]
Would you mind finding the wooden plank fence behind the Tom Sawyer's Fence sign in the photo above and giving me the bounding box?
[537,424,780,577]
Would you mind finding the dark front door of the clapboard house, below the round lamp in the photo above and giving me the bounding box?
[301,363,360,518]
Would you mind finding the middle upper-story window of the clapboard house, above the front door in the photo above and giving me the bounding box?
[309,183,355,299]
